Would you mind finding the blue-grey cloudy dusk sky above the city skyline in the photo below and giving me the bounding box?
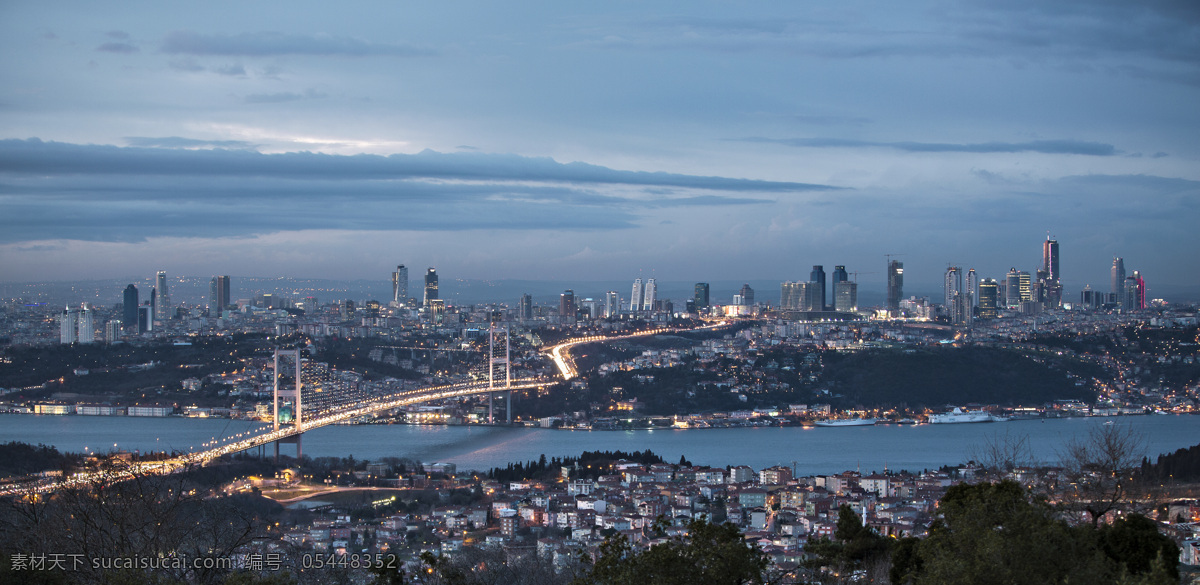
[0,0,1200,298]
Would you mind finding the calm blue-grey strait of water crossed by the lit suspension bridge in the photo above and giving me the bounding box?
[0,415,1200,475]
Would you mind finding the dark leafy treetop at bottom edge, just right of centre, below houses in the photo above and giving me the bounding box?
[572,518,767,585]
